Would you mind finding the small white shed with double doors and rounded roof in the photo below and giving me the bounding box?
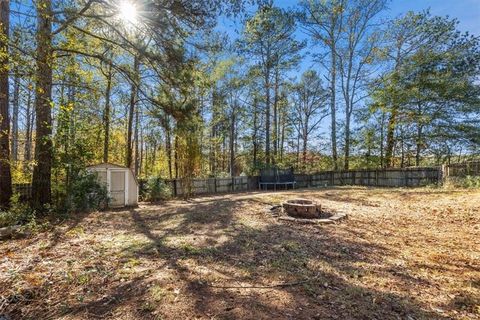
[87,163,138,207]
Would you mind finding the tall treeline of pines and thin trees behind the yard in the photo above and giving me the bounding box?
[0,0,480,207]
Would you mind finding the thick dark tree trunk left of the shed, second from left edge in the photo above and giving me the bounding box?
[32,0,53,208]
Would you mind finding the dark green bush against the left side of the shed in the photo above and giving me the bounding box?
[63,171,108,212]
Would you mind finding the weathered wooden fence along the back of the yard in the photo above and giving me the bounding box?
[14,167,445,199]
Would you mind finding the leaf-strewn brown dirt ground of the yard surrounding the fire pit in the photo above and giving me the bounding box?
[0,188,480,320]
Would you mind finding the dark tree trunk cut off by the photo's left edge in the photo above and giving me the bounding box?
[0,0,12,209]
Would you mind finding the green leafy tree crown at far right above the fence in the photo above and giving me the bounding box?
[371,12,480,165]
